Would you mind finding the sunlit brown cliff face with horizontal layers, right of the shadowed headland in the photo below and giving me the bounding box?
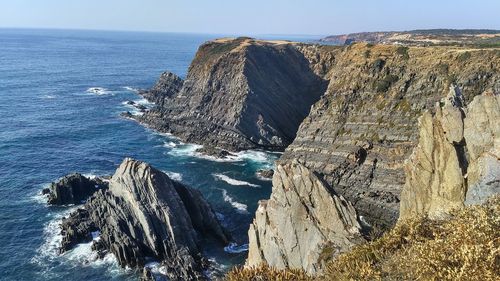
[279,44,500,229]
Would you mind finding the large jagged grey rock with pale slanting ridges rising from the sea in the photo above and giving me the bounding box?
[62,158,228,280]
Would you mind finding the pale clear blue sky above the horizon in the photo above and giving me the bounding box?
[0,0,500,35]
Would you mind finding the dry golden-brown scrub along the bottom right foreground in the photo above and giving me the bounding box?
[227,196,500,281]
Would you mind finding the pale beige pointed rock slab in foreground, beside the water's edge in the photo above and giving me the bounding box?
[246,161,364,274]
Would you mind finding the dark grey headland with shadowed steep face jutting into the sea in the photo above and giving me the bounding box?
[138,38,326,151]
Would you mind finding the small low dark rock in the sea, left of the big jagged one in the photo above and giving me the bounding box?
[42,173,107,205]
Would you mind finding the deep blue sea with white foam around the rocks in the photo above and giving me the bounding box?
[0,29,286,281]
